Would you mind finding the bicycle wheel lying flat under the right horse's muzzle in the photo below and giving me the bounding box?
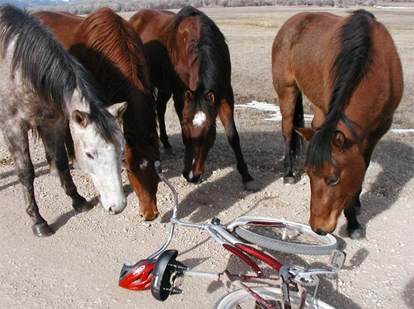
[234,218,338,255]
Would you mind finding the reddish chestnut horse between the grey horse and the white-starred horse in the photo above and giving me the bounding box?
[35,8,160,220]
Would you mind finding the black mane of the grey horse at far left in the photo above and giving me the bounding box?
[0,5,116,141]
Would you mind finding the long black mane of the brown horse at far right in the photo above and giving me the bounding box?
[307,10,375,167]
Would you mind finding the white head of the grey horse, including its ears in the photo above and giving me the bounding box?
[69,91,126,213]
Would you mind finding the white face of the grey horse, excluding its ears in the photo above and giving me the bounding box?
[70,90,126,213]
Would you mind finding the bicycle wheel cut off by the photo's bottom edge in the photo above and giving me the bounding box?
[214,286,334,309]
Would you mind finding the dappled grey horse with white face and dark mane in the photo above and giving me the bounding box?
[0,5,126,236]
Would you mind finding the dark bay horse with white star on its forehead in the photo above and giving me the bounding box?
[129,6,258,191]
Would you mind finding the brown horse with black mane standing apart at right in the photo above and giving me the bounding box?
[272,10,403,239]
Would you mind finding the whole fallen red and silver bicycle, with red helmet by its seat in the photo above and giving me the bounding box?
[119,161,345,309]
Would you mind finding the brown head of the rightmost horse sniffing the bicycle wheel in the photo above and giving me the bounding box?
[296,128,367,235]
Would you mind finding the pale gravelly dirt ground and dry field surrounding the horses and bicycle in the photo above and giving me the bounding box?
[0,7,414,309]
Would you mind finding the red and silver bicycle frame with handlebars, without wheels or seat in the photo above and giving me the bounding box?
[119,161,343,309]
